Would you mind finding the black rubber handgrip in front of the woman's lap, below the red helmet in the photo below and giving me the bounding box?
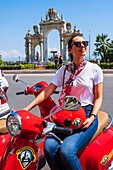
[54,126,73,135]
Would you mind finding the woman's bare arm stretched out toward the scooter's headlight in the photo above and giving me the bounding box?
[24,83,57,111]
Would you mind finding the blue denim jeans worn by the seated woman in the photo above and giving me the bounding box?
[44,105,98,170]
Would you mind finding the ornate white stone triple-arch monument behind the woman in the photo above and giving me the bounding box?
[25,8,79,63]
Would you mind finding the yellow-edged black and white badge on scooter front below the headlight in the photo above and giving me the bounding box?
[16,146,36,169]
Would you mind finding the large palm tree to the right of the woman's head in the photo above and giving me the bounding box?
[93,33,110,62]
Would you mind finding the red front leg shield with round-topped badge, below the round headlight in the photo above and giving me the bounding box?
[0,136,42,170]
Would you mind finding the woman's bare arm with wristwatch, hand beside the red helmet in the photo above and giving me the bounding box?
[83,83,103,128]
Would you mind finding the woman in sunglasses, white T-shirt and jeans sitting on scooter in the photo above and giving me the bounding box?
[25,33,103,170]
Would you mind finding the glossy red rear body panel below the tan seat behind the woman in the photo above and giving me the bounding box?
[79,128,113,170]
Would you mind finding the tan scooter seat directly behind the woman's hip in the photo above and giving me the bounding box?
[90,111,109,142]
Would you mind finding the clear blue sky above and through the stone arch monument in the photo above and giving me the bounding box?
[0,0,113,61]
